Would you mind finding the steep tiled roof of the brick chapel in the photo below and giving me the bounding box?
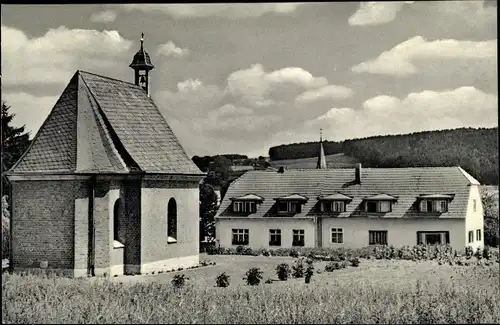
[7,71,202,175]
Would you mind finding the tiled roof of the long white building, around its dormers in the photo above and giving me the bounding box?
[216,167,477,218]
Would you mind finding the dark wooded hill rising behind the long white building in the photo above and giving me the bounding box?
[269,127,498,185]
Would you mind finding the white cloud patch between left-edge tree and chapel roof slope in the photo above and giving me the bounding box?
[2,92,58,138]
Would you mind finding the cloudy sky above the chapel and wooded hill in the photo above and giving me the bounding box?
[1,1,498,157]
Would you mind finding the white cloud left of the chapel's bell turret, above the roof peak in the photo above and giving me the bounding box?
[2,25,132,86]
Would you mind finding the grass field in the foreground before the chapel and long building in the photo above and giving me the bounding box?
[2,256,500,324]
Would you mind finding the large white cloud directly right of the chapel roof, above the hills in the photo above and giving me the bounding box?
[153,64,352,155]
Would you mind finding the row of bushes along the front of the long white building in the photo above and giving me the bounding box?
[207,245,499,261]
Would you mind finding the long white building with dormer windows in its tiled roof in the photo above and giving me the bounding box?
[216,143,484,250]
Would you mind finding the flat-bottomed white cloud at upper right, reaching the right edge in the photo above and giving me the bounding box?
[351,36,497,76]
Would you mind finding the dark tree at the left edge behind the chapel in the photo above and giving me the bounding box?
[2,102,30,194]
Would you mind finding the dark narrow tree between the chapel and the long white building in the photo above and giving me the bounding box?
[200,182,218,240]
